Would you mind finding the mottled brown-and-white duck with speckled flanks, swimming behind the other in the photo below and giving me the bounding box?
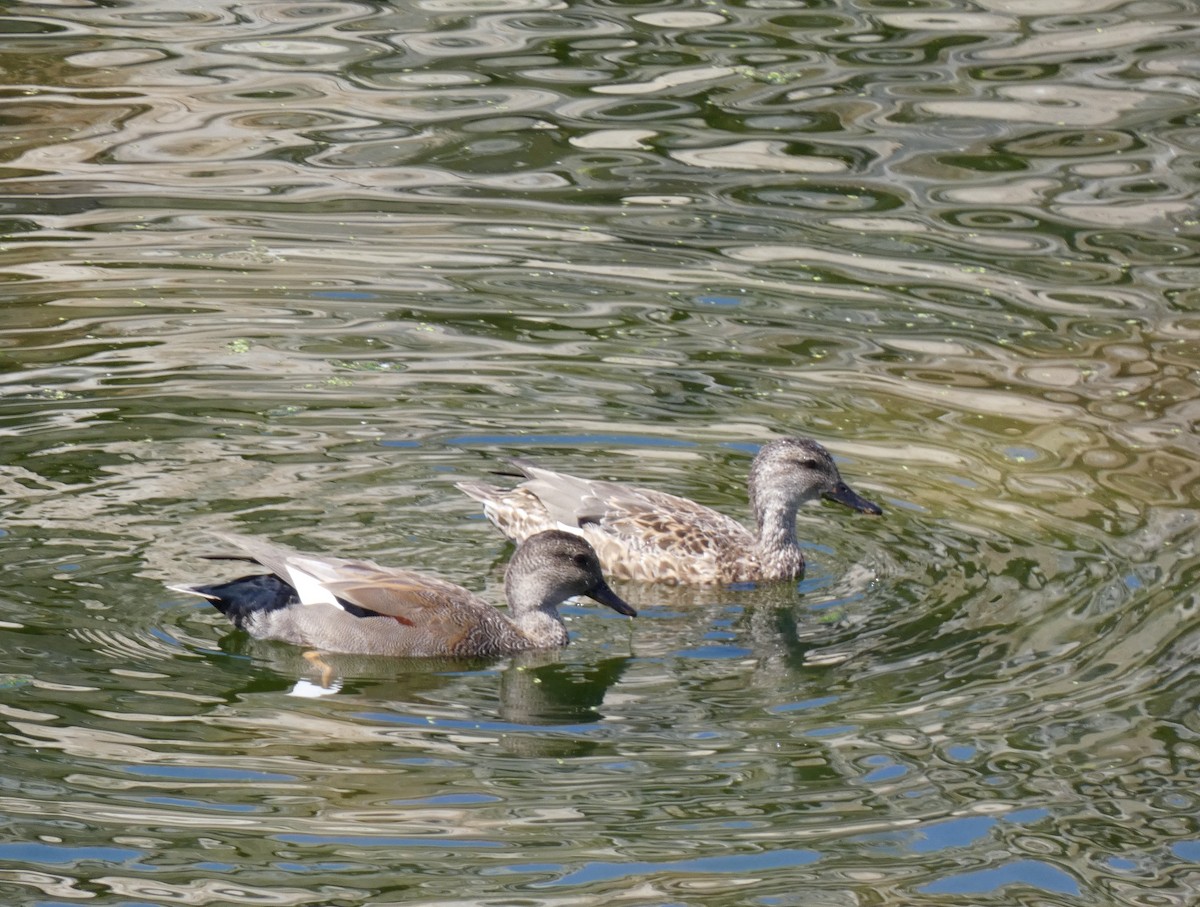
[456,438,883,585]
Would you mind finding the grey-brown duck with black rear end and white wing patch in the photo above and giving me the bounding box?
[169,529,637,657]
